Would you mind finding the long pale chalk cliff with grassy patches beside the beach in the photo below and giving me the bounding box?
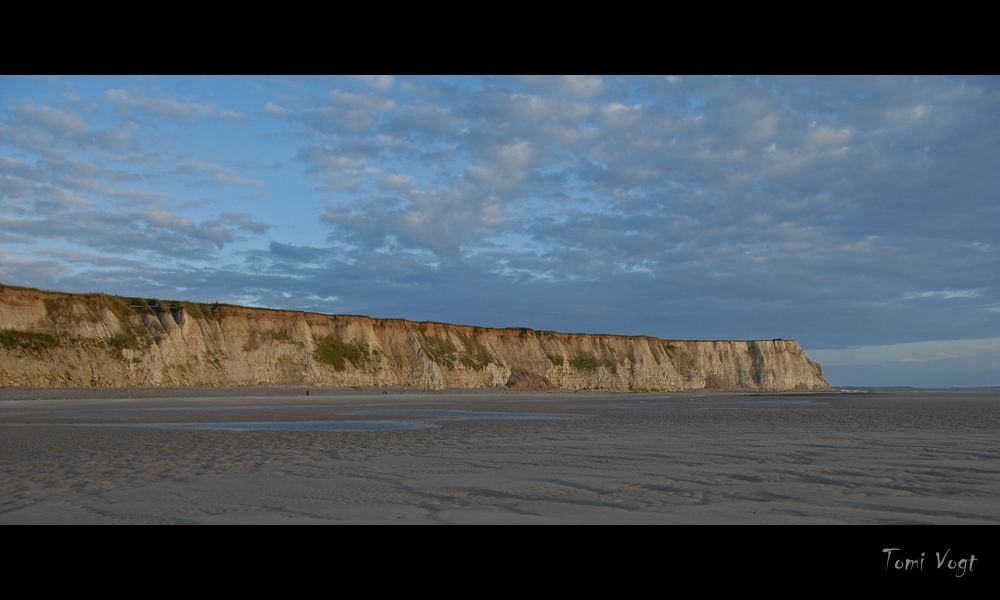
[0,286,831,391]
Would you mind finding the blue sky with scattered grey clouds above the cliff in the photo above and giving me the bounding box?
[0,76,1000,387]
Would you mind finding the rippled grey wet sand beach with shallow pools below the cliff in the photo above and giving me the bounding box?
[0,387,1000,524]
